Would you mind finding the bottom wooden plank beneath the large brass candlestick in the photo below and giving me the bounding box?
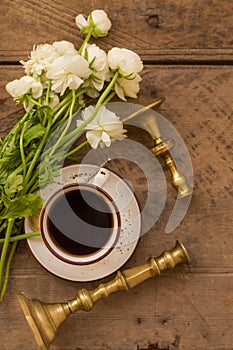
[0,271,233,350]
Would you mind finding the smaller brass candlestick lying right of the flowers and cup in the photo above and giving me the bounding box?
[142,115,192,198]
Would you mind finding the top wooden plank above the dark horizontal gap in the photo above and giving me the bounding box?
[0,0,233,62]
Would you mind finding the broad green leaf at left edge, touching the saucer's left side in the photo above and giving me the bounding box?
[0,193,43,219]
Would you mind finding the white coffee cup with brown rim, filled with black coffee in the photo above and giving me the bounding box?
[39,168,121,265]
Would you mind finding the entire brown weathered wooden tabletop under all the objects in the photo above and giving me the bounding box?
[0,0,233,350]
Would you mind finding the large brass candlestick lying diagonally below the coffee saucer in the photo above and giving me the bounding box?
[18,240,190,350]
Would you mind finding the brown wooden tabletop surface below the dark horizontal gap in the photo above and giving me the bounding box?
[0,65,233,350]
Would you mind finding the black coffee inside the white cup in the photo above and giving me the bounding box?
[48,189,113,255]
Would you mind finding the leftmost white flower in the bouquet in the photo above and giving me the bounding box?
[6,75,43,100]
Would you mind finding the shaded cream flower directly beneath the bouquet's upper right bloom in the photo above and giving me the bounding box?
[115,74,142,101]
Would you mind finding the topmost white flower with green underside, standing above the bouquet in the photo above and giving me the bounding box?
[75,10,112,38]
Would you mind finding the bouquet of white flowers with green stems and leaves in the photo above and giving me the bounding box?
[0,10,143,300]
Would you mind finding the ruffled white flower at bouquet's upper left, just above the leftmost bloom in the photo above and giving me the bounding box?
[20,44,59,77]
